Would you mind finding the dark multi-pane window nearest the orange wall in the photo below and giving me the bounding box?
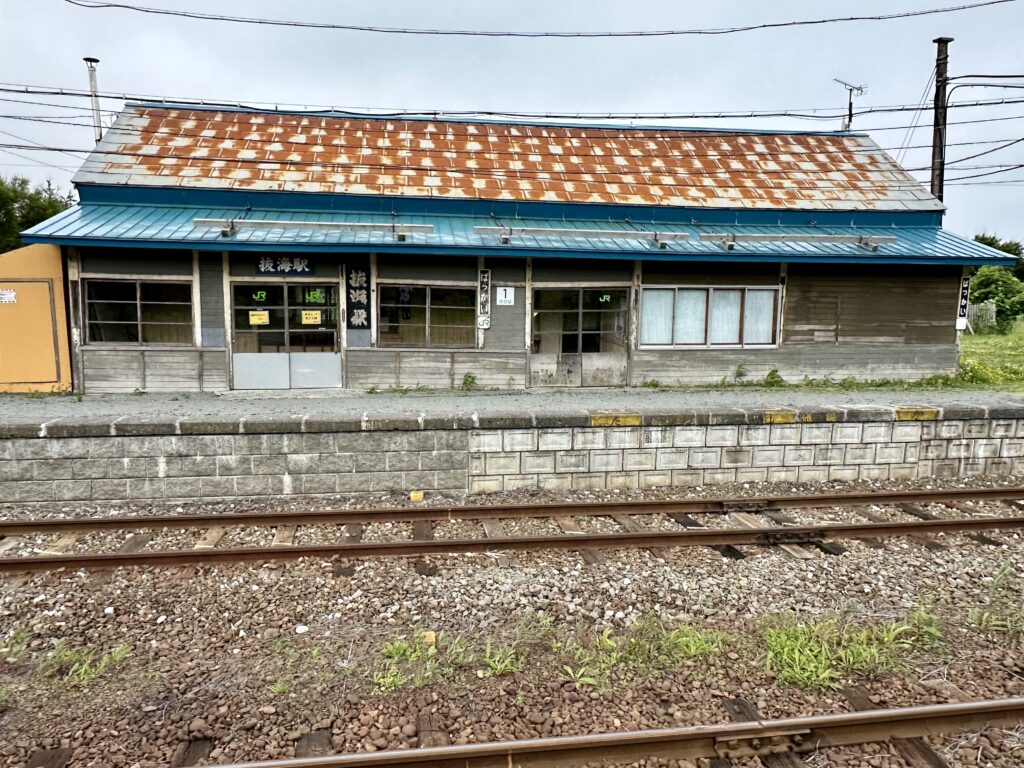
[85,280,195,345]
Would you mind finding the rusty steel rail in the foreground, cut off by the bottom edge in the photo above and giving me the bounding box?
[201,698,1024,768]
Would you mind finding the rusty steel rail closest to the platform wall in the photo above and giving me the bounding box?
[0,487,1024,536]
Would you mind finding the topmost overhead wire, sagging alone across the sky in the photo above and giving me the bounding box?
[65,0,1016,38]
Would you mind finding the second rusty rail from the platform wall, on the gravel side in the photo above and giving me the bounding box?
[0,517,1024,572]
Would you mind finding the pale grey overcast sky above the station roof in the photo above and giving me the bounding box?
[0,0,1024,240]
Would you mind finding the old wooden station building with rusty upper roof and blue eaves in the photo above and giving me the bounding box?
[23,103,1013,392]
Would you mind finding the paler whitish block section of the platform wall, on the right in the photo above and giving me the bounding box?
[469,409,1024,493]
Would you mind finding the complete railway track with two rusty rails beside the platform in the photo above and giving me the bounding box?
[0,487,1024,573]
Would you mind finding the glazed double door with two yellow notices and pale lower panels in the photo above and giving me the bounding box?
[231,283,342,389]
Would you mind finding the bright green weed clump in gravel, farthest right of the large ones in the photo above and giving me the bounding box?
[764,606,942,688]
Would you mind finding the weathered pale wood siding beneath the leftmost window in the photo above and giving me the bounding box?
[82,346,227,393]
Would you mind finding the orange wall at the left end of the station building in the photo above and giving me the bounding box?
[0,245,72,392]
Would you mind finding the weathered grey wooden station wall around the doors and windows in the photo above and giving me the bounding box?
[70,250,962,392]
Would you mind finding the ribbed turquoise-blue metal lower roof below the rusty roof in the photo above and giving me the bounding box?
[22,203,1015,265]
